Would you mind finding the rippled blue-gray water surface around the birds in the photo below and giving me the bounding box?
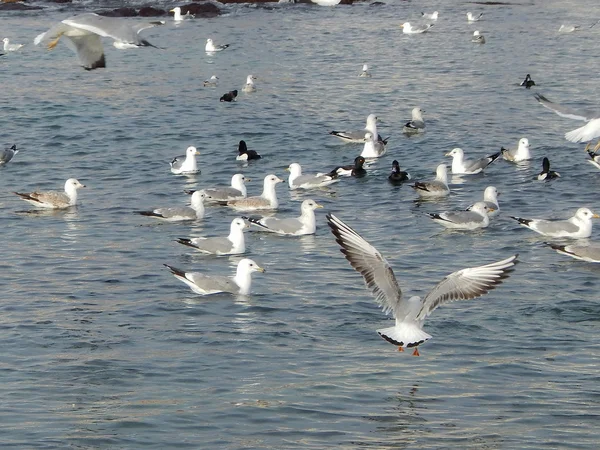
[0,0,600,449]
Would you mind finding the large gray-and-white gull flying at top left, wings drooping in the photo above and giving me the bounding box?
[33,13,164,70]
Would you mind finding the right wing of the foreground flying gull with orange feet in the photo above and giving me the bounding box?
[417,255,518,320]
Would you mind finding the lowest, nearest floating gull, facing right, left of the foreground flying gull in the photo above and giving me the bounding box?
[165,258,265,295]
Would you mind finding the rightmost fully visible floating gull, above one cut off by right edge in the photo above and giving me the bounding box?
[510,208,600,239]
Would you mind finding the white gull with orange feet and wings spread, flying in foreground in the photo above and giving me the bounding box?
[327,214,518,356]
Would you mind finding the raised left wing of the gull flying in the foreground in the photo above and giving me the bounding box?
[327,214,405,318]
